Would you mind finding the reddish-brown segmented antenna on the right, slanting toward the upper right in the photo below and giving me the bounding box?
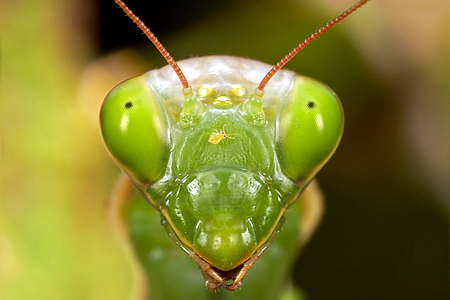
[255,0,369,96]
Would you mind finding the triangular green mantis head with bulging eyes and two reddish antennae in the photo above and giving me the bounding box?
[100,0,368,291]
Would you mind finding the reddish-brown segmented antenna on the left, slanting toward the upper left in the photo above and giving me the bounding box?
[114,0,192,96]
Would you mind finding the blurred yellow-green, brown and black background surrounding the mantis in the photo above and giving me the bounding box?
[0,0,450,299]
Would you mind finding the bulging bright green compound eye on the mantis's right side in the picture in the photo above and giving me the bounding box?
[276,76,344,182]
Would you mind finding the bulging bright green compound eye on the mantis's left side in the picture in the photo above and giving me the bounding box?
[100,76,169,185]
